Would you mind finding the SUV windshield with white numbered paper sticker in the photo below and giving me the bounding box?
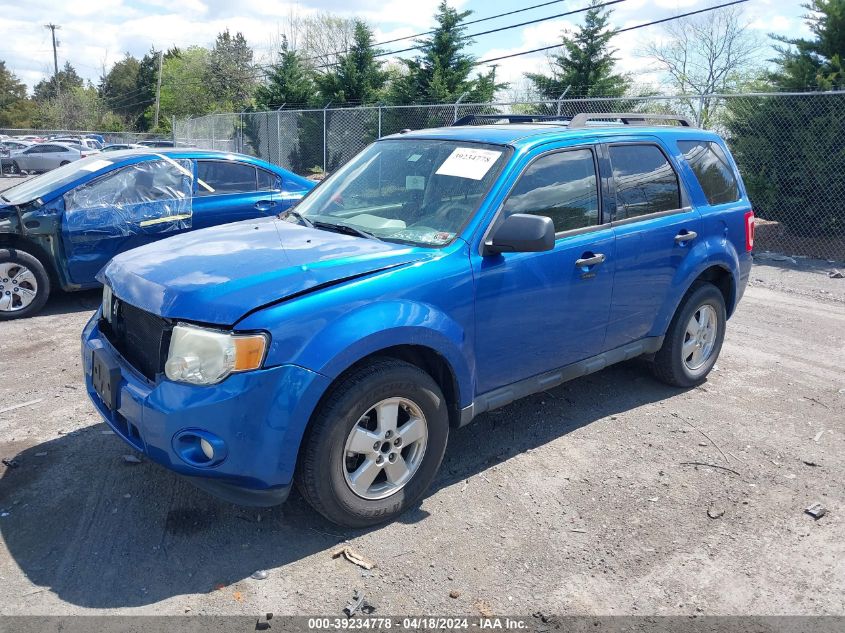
[288,138,508,246]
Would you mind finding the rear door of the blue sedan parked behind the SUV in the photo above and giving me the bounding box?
[193,160,278,228]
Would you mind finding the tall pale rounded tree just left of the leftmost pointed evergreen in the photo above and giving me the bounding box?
[208,29,255,111]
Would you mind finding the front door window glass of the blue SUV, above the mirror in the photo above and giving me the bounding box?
[503,149,599,233]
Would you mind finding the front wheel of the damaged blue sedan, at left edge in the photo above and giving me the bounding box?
[0,248,50,321]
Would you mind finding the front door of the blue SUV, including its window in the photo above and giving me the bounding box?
[473,147,615,394]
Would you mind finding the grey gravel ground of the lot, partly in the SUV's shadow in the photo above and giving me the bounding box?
[0,253,845,616]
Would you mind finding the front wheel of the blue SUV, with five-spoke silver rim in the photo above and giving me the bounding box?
[296,359,449,528]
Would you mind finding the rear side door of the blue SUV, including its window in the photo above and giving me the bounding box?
[603,139,701,349]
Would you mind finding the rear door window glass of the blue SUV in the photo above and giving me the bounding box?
[610,145,681,220]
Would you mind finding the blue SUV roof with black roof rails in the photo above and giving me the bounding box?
[385,121,717,148]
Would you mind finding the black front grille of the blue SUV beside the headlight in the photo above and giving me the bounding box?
[100,299,172,380]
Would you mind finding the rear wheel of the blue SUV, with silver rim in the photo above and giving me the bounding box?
[652,283,727,387]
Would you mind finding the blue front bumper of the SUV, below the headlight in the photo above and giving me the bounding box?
[82,312,329,506]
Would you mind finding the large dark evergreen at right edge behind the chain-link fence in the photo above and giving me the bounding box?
[727,0,845,239]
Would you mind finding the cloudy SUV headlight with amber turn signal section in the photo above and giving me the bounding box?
[164,323,267,385]
